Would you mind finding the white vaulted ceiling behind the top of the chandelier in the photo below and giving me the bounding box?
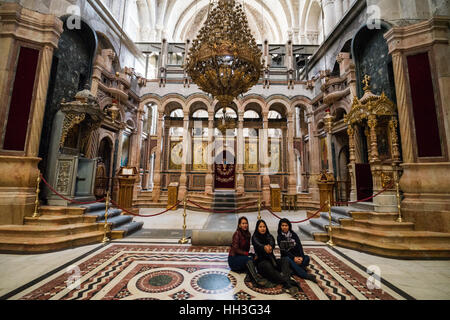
[126,0,321,44]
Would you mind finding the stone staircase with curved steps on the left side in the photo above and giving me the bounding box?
[0,203,142,253]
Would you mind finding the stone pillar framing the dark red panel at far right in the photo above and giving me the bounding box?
[384,16,450,232]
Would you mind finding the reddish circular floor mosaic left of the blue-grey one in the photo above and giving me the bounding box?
[136,270,184,293]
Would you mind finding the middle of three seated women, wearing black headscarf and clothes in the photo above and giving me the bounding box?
[252,220,299,295]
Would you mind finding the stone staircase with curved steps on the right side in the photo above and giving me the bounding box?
[299,204,450,259]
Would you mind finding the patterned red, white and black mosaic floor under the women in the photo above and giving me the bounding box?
[5,242,409,300]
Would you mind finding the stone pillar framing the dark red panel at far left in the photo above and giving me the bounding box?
[0,2,63,224]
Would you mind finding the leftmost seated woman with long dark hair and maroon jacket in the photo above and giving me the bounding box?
[228,217,267,286]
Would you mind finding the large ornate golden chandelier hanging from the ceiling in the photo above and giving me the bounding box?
[185,0,263,107]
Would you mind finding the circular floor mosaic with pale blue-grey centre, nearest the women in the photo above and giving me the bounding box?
[191,270,237,294]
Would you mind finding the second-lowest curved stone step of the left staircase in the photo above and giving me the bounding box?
[0,223,100,239]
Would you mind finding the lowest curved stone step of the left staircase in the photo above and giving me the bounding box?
[0,231,103,253]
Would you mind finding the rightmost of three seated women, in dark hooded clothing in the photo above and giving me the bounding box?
[277,219,316,282]
